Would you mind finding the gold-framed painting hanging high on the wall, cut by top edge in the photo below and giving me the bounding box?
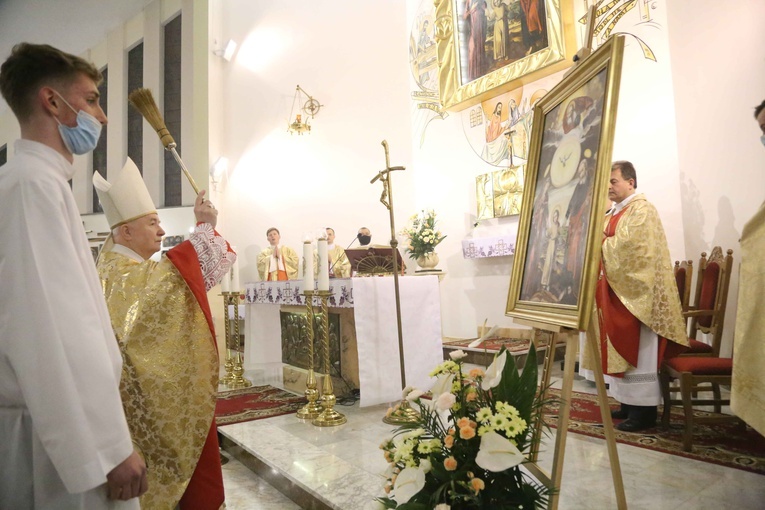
[435,0,577,110]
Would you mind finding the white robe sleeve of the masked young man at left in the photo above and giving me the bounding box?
[0,176,133,493]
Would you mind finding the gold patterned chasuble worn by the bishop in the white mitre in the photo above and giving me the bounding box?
[98,252,218,510]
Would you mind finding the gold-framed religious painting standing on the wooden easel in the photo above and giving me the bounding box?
[505,36,624,330]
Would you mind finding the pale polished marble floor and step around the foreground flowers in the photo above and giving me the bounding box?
[219,364,765,510]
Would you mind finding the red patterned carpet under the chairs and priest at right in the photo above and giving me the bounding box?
[545,389,765,475]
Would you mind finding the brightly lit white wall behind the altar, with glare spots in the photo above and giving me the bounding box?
[210,0,414,282]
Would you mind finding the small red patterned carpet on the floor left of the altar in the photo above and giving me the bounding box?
[215,385,306,426]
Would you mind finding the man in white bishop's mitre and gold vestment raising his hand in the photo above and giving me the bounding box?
[93,159,236,510]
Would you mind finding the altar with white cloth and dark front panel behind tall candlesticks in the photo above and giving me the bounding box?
[244,275,443,406]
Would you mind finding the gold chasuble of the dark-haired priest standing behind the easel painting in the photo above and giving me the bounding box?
[602,194,689,373]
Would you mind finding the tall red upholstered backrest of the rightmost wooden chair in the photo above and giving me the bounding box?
[675,246,733,357]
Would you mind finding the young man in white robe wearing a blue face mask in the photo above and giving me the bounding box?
[0,43,146,510]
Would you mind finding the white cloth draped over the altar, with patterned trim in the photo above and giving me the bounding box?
[244,275,443,407]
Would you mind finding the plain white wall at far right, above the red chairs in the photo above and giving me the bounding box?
[667,0,765,354]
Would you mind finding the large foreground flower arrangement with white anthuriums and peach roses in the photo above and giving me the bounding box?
[378,346,551,510]
